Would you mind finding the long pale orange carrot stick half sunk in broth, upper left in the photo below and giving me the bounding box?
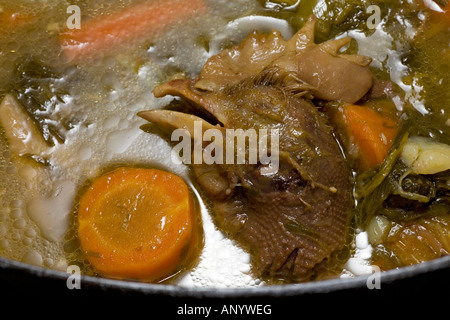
[60,0,206,61]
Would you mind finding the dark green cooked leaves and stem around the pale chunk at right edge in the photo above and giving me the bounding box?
[354,112,450,228]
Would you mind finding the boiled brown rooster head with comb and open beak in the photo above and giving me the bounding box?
[139,17,372,282]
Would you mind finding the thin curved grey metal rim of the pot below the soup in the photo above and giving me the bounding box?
[0,255,450,299]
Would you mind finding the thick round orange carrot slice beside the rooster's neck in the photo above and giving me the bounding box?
[78,167,200,281]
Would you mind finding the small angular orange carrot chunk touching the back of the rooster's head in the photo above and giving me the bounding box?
[343,105,397,170]
